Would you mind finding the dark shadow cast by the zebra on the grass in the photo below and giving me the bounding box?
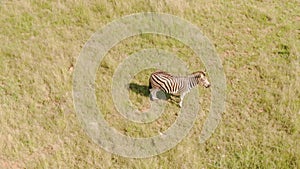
[129,83,171,100]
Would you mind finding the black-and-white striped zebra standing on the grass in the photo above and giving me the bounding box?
[149,70,210,107]
